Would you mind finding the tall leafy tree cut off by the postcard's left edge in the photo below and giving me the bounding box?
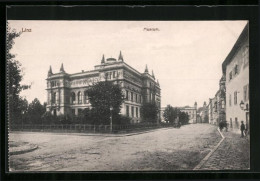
[6,27,22,123]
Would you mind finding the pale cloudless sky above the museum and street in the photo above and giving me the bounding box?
[8,20,247,107]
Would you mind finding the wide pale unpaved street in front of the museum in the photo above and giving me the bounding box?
[9,124,221,171]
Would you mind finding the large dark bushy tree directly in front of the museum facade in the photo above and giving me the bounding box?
[87,80,124,124]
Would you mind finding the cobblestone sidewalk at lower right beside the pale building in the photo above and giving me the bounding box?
[199,131,250,170]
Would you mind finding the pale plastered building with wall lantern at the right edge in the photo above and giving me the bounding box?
[222,24,250,130]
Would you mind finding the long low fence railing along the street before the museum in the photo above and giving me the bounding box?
[10,123,177,133]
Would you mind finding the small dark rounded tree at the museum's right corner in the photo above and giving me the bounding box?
[141,103,159,123]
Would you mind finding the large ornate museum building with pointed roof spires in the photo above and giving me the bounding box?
[46,51,161,123]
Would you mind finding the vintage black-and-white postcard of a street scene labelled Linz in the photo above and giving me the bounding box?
[6,20,250,172]
